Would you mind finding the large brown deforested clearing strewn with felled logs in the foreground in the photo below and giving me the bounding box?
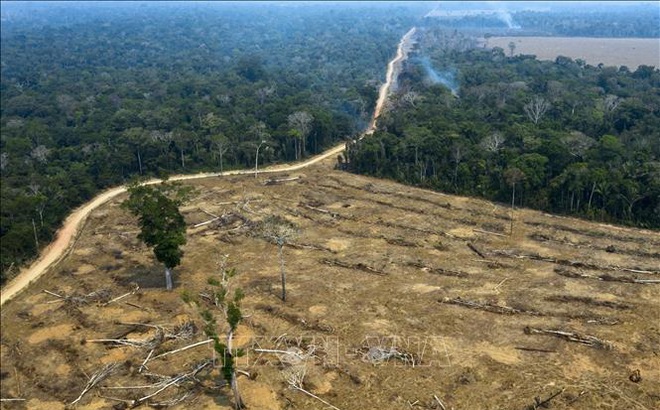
[0,160,660,410]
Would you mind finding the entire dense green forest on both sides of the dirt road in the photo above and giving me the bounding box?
[0,2,660,281]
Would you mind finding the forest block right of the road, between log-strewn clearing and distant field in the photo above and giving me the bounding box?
[343,30,660,229]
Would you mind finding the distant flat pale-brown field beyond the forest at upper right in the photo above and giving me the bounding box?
[486,37,660,70]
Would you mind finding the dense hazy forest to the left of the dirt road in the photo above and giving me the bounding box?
[0,2,428,280]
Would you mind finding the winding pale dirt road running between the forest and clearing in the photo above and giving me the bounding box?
[0,27,415,306]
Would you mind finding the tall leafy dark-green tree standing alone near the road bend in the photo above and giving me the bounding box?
[122,183,189,290]
